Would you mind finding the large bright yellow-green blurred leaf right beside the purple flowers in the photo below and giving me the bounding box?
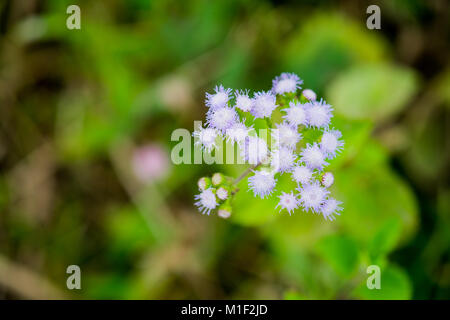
[332,142,418,245]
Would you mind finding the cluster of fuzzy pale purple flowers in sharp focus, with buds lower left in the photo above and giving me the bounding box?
[193,73,344,220]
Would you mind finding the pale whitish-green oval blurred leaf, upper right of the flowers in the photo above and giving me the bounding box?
[327,64,418,120]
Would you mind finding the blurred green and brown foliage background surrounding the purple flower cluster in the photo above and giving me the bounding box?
[0,0,450,299]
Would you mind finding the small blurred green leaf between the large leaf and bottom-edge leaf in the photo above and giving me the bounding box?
[317,235,359,277]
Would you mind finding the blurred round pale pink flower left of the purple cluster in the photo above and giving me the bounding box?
[132,143,170,182]
